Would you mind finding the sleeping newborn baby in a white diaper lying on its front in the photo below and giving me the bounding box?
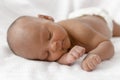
[7,9,120,71]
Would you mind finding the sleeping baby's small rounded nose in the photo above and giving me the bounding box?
[50,41,62,52]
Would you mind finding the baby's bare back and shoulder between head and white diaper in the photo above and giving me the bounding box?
[58,16,111,52]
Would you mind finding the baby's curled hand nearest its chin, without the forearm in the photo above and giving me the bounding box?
[66,46,85,64]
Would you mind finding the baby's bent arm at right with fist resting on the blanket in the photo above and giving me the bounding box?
[81,40,114,71]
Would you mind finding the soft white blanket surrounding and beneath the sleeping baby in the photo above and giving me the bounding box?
[0,0,120,80]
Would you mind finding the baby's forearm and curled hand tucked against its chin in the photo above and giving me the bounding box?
[57,46,85,65]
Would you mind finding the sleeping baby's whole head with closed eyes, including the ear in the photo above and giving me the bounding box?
[7,15,71,61]
